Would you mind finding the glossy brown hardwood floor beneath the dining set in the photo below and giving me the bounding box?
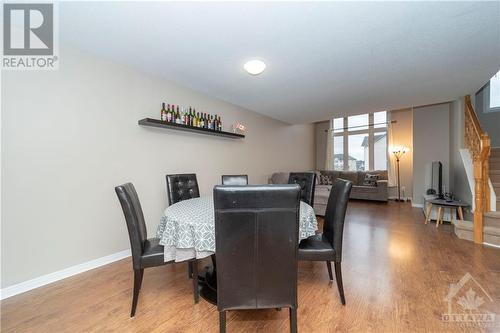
[1,201,500,333]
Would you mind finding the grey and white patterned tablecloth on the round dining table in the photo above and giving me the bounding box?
[156,197,318,261]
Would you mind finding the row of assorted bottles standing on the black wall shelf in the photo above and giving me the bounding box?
[160,103,222,131]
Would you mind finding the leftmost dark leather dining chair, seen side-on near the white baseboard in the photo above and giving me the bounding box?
[115,183,199,317]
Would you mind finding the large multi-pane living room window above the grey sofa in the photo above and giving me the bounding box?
[332,111,387,171]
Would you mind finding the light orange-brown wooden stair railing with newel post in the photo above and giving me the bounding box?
[464,95,490,244]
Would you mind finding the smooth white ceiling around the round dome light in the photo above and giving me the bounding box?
[59,2,500,123]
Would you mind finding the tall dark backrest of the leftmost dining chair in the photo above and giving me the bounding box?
[115,183,148,269]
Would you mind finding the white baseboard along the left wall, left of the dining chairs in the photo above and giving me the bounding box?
[0,249,131,300]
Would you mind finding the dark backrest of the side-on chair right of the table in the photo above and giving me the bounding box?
[323,178,352,262]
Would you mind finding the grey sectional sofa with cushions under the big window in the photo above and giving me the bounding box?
[269,170,388,215]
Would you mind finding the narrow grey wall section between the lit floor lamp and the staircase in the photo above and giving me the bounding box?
[413,103,451,204]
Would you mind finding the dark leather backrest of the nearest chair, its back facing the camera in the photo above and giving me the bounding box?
[214,184,300,311]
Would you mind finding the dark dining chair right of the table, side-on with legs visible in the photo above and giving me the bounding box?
[299,178,352,305]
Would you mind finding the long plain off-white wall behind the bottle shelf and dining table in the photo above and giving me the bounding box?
[1,47,314,287]
